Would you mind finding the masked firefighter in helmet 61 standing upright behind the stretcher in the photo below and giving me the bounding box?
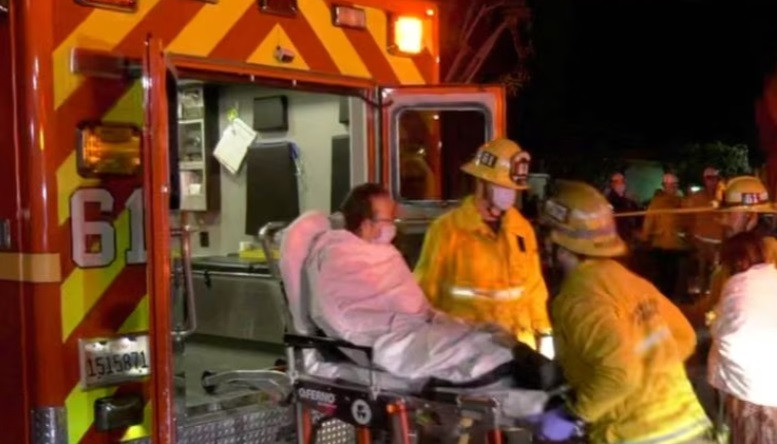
[415,139,550,349]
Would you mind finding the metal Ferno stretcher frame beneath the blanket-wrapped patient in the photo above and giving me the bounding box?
[196,222,529,444]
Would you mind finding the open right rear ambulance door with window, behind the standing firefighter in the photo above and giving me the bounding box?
[376,85,506,266]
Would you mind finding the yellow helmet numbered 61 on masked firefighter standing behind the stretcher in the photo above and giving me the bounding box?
[461,139,531,190]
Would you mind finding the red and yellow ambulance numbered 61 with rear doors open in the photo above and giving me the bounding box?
[0,0,505,444]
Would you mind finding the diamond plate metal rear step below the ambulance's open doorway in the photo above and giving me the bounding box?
[177,405,296,444]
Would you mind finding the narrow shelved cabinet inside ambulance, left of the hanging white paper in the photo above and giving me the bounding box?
[178,81,221,211]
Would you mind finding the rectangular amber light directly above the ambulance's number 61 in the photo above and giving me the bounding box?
[78,124,141,177]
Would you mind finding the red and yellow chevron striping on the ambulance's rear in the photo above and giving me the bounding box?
[47,0,438,443]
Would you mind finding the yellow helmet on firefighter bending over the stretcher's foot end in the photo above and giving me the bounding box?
[541,181,627,257]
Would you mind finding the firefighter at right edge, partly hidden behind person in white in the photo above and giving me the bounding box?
[701,176,777,321]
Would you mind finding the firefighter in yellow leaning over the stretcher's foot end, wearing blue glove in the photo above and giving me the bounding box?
[542,182,711,444]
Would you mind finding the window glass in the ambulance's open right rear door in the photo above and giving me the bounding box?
[398,109,487,201]
